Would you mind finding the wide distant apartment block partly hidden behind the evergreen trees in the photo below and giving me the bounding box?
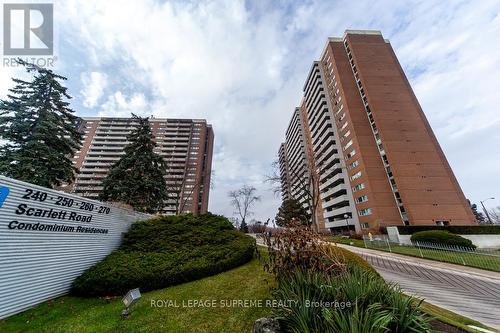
[67,118,214,214]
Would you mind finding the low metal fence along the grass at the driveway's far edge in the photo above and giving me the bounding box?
[363,235,500,272]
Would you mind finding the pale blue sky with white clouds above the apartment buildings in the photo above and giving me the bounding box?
[0,0,500,220]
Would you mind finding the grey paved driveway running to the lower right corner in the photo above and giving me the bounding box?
[339,245,500,329]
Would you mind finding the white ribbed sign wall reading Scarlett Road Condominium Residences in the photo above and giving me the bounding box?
[0,176,150,319]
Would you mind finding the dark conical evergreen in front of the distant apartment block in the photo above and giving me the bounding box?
[101,114,167,213]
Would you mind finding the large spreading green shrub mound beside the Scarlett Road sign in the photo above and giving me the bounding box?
[71,214,255,297]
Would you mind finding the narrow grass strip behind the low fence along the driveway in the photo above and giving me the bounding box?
[325,236,500,272]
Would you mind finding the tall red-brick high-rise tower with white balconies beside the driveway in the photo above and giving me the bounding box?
[280,30,474,231]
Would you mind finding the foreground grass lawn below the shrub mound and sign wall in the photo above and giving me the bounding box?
[0,255,273,333]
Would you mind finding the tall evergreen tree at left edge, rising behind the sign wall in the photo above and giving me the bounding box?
[0,59,82,188]
